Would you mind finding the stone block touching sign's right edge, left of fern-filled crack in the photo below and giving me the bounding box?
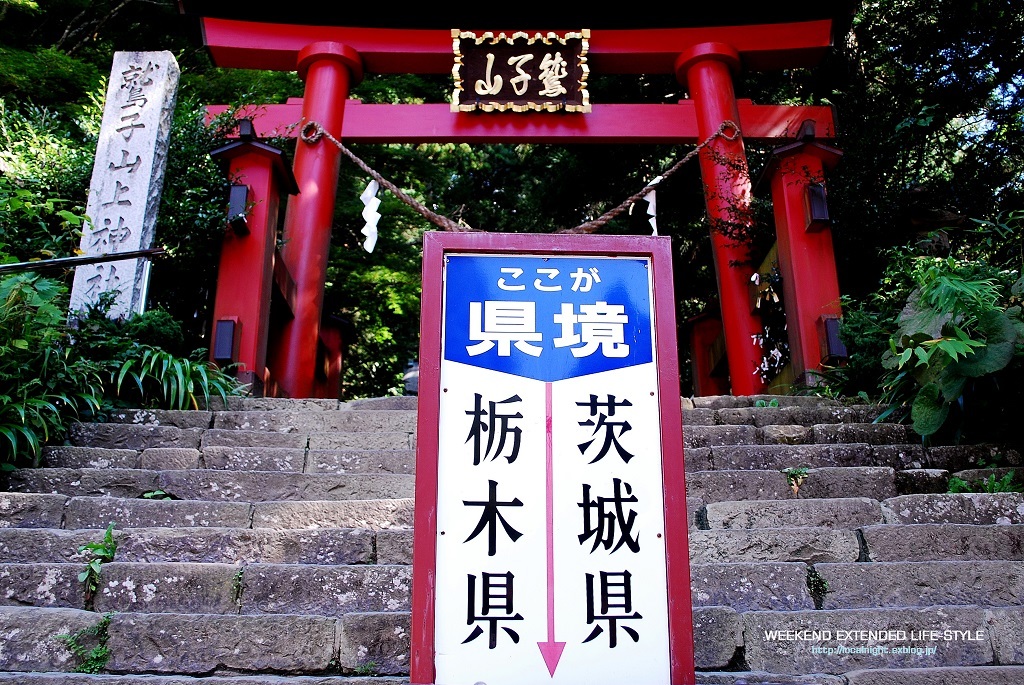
[690,563,814,611]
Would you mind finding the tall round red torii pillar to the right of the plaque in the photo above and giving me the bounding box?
[678,44,765,395]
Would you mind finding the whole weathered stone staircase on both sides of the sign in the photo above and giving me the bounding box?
[0,397,1024,685]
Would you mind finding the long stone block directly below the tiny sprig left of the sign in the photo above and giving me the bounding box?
[66,498,250,528]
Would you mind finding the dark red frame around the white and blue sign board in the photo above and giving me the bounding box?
[410,231,695,685]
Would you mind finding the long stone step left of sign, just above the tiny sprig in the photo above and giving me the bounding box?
[6,468,414,502]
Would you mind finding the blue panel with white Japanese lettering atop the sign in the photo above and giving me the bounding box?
[443,255,653,382]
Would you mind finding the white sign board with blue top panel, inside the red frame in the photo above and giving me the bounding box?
[414,235,692,685]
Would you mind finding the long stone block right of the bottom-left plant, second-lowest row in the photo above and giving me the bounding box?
[108,613,336,674]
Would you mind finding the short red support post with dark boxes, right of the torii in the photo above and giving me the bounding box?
[765,124,846,385]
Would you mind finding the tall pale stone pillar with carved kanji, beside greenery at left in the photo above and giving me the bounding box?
[71,51,180,318]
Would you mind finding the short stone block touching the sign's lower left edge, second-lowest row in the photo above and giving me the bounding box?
[338,612,410,675]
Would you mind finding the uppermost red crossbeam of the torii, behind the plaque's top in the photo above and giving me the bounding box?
[202,17,831,74]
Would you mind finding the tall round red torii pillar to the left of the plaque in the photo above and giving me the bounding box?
[273,42,362,397]
